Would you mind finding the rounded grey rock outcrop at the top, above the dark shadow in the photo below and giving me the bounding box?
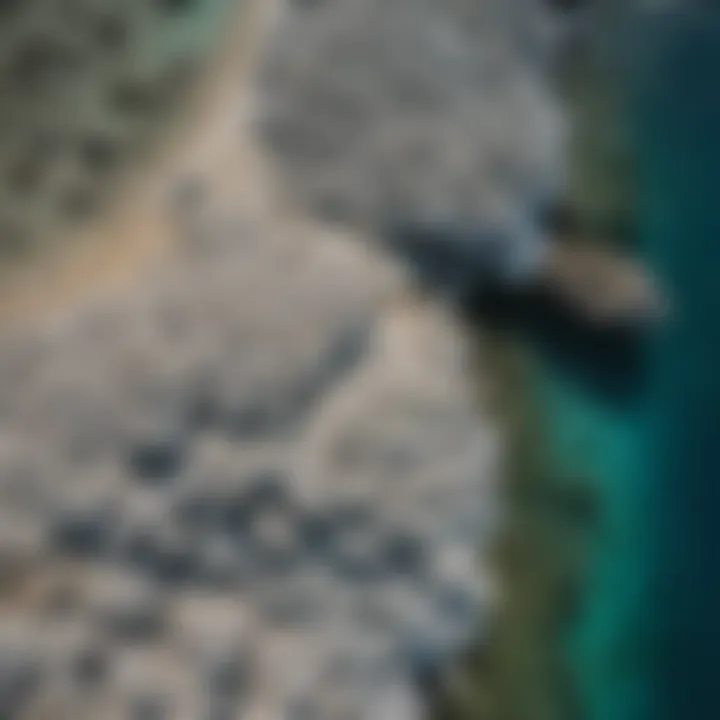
[258,0,564,229]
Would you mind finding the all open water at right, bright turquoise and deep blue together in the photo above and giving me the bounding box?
[534,11,720,720]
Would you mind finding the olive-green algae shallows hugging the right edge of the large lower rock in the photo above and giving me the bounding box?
[435,332,600,720]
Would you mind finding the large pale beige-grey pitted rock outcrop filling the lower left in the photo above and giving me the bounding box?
[0,198,496,718]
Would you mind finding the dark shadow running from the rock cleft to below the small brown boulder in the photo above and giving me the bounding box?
[384,218,650,407]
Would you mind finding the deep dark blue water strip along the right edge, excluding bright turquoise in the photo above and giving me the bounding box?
[638,9,720,720]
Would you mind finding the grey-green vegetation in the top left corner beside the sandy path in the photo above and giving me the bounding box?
[0,0,236,264]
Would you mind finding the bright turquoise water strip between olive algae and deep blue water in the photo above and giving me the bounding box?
[535,358,653,720]
